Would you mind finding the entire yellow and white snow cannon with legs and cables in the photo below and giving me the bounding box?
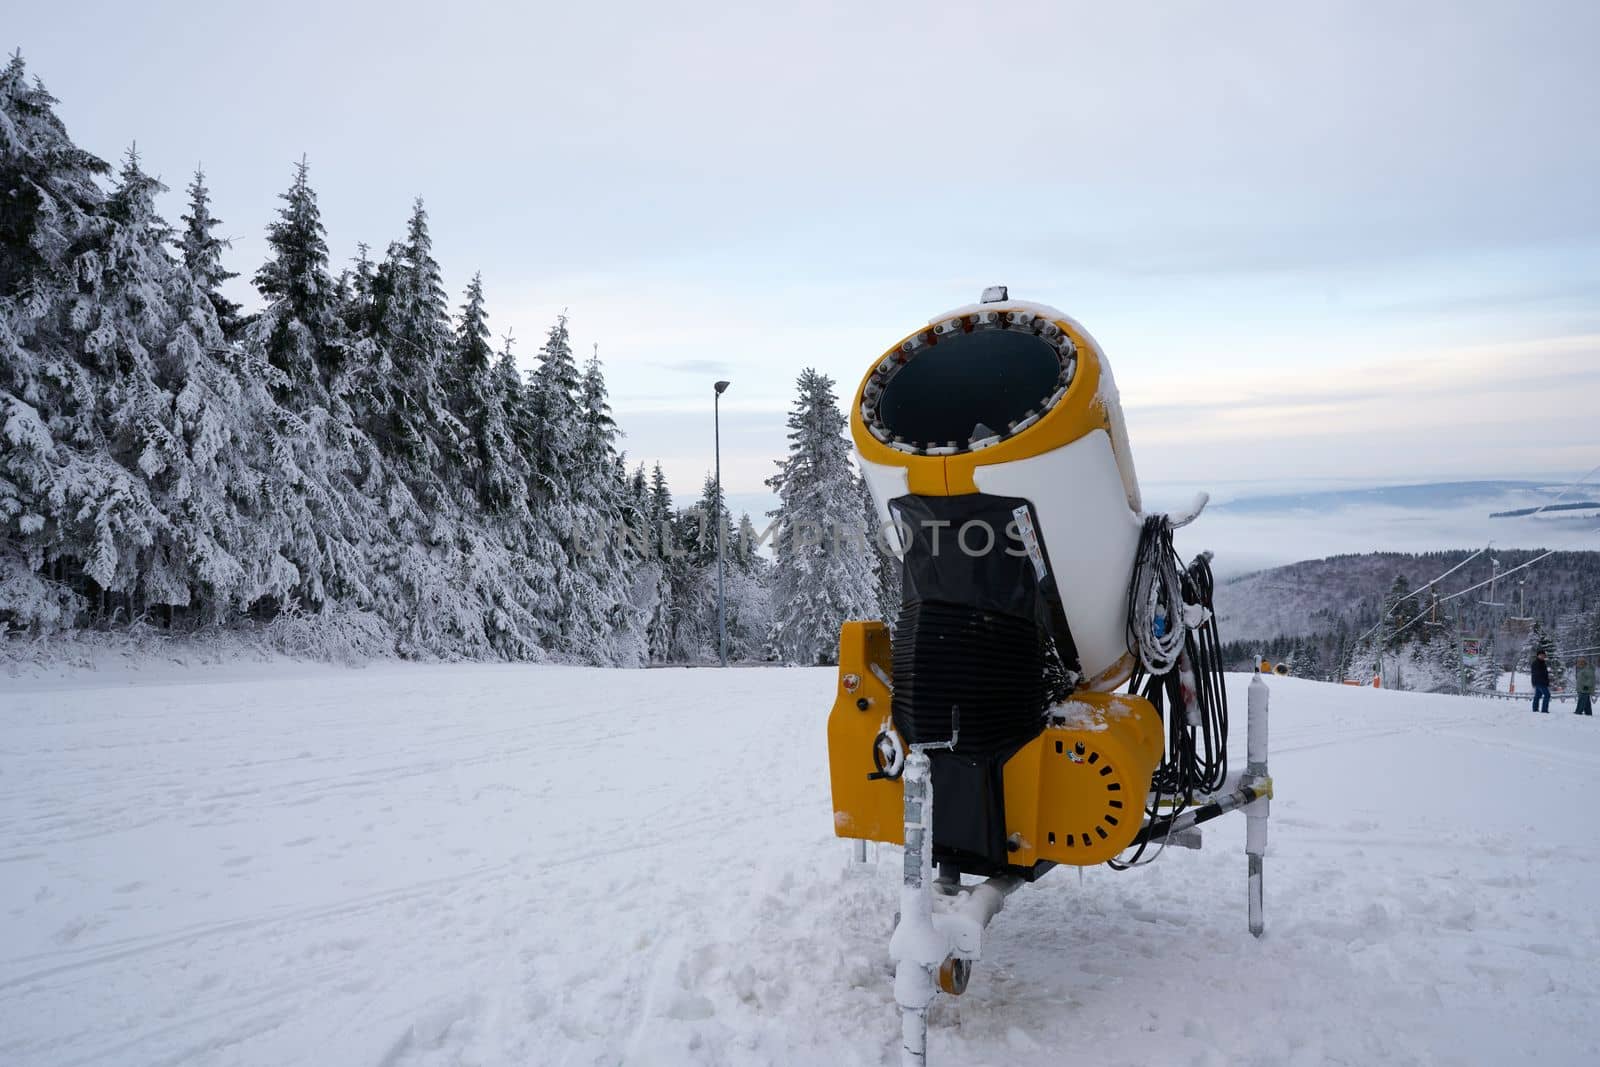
[827,286,1270,1064]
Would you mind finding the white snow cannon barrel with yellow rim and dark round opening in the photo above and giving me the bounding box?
[850,292,1141,691]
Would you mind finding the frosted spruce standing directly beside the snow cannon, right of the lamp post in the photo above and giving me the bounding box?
[766,368,878,664]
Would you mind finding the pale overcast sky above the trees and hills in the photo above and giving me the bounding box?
[5,0,1600,515]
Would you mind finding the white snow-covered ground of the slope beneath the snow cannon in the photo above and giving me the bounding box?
[0,665,1600,1067]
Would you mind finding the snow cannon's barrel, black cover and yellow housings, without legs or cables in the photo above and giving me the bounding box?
[829,288,1162,878]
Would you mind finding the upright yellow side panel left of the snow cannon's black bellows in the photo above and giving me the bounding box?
[827,621,906,845]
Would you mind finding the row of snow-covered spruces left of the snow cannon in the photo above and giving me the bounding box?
[0,56,880,665]
